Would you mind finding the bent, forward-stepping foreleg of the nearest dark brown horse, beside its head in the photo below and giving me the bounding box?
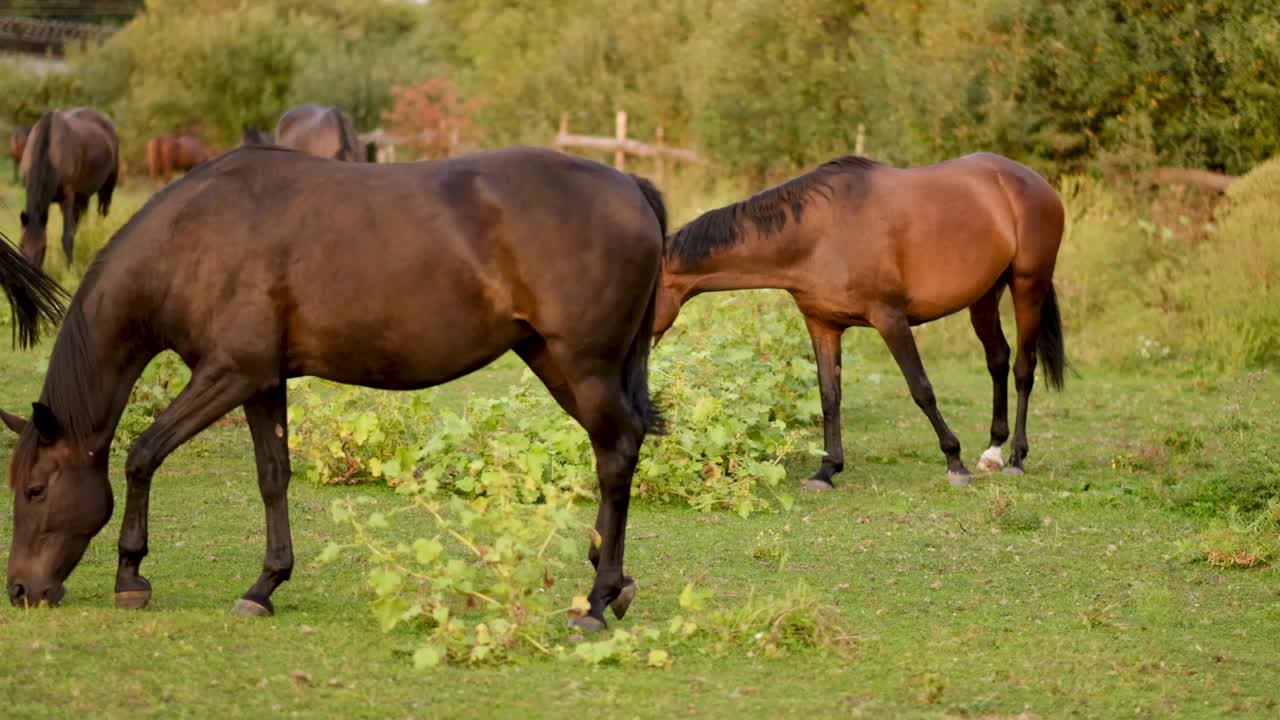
[115,363,252,610]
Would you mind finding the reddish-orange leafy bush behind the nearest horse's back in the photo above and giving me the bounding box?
[383,77,481,158]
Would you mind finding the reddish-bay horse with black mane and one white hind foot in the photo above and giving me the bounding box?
[654,154,1066,491]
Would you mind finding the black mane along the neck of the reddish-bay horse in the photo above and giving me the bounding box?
[667,155,881,265]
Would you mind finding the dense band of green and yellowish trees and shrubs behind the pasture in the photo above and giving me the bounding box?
[0,0,1280,179]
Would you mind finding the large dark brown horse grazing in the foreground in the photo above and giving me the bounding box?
[8,147,666,629]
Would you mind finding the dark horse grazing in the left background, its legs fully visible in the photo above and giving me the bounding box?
[22,108,120,268]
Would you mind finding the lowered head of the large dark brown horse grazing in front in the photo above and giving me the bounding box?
[0,402,113,606]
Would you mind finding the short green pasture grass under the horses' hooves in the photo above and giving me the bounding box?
[0,322,1280,717]
